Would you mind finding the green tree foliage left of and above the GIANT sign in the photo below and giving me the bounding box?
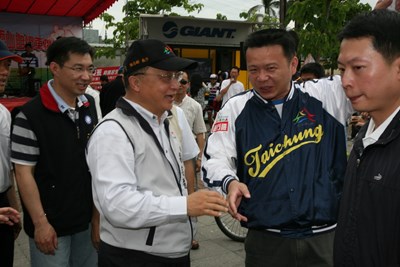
[96,0,204,58]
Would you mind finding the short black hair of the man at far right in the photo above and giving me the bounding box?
[338,9,400,63]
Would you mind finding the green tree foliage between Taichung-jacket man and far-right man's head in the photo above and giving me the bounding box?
[286,0,371,73]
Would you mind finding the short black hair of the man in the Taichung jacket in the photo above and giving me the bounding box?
[243,29,298,60]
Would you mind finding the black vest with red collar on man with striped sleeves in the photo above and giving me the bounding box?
[12,83,97,237]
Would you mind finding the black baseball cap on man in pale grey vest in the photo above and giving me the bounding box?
[124,39,198,76]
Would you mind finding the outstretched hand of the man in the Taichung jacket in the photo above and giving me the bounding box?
[227,180,251,222]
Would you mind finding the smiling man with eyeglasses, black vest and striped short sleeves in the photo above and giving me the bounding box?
[11,37,98,267]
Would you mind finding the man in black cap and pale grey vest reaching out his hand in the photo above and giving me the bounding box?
[87,39,227,267]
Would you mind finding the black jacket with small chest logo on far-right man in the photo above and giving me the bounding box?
[334,112,400,267]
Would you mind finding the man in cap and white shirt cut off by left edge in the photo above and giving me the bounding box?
[0,41,22,267]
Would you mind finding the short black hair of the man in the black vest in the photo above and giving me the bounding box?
[46,37,95,66]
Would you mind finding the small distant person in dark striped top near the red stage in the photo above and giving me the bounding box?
[18,43,39,97]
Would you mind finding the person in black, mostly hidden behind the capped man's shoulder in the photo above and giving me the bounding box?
[100,67,125,116]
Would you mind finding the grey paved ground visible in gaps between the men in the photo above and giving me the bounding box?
[14,216,245,267]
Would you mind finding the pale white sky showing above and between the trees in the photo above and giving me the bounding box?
[92,0,377,37]
